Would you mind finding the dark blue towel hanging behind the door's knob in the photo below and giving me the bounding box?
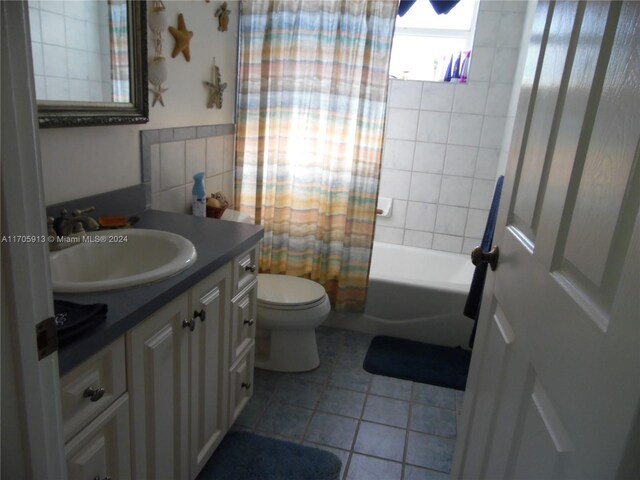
[464,175,504,348]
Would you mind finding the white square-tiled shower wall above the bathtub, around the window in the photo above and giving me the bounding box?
[375,1,526,253]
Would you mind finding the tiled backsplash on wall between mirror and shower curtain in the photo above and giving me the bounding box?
[140,124,235,213]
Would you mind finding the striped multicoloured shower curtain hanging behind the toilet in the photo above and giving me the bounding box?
[235,0,397,312]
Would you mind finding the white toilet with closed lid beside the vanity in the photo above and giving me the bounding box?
[255,274,331,372]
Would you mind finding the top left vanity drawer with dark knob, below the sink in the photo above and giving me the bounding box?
[60,337,127,442]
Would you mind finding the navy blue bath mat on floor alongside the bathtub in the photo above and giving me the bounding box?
[364,336,471,390]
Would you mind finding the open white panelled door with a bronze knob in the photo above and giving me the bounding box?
[452,1,640,479]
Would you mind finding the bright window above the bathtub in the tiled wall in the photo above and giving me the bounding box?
[390,0,479,81]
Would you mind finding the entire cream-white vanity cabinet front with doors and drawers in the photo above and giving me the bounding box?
[61,248,257,480]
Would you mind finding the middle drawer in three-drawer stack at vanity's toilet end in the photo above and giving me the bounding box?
[229,279,258,365]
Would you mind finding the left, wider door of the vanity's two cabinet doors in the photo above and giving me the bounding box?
[127,294,191,479]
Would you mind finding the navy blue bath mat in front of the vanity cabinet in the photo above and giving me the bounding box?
[196,432,342,480]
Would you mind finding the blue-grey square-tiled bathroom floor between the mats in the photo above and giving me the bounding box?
[233,327,463,480]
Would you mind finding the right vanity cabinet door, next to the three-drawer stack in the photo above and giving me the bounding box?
[189,264,231,478]
